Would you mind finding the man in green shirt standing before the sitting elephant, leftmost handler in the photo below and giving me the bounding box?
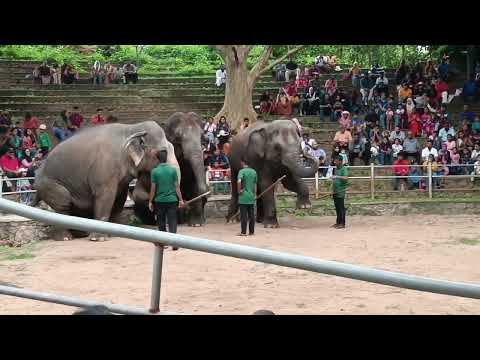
[148,150,184,250]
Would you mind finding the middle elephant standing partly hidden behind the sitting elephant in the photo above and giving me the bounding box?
[134,112,208,226]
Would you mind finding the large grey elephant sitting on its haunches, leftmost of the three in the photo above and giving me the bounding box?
[33,121,181,241]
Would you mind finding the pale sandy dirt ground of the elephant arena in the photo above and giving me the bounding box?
[0,216,480,314]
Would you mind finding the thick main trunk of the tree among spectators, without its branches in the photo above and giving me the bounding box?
[215,48,257,130]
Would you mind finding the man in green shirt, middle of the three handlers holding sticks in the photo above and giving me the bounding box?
[237,160,257,236]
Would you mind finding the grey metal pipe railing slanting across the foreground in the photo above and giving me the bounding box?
[0,199,480,314]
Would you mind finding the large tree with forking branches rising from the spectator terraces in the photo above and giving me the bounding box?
[211,45,304,129]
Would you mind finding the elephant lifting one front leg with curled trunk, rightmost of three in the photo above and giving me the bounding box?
[227,120,319,228]
